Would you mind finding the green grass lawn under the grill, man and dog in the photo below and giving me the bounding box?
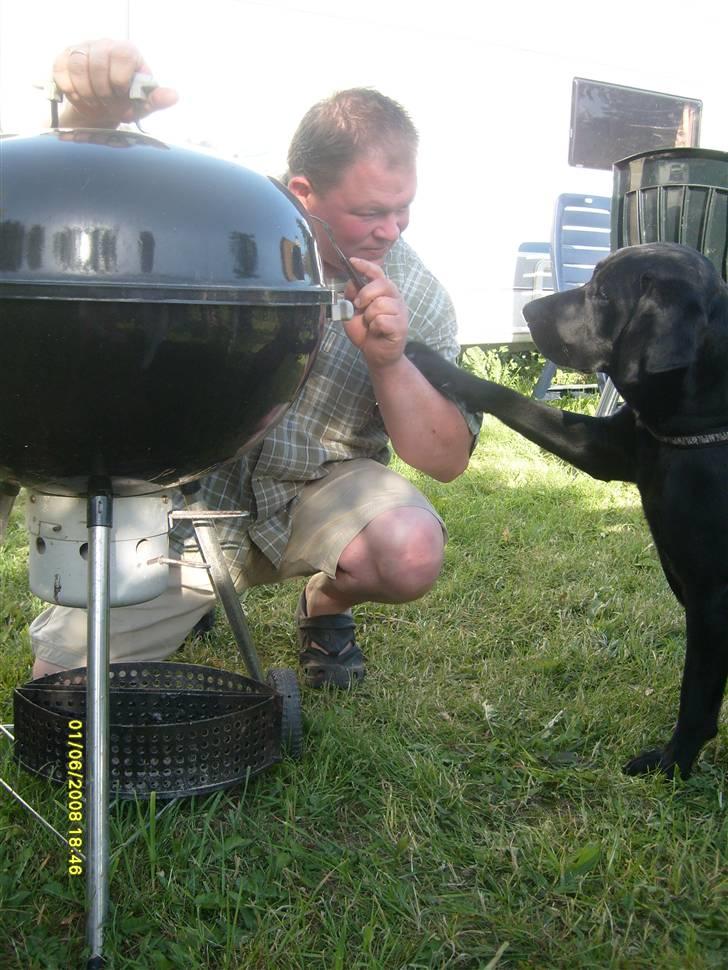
[0,390,728,970]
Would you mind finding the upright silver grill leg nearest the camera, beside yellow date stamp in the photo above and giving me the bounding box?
[85,482,112,970]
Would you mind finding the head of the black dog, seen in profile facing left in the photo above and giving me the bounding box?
[523,243,726,389]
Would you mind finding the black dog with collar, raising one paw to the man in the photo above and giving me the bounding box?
[407,243,728,778]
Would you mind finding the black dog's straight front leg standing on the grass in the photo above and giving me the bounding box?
[624,587,728,778]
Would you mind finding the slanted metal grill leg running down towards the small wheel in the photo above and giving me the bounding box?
[182,483,265,683]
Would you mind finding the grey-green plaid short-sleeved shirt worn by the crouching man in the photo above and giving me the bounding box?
[173,239,480,567]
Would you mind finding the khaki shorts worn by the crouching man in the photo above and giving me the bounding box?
[29,458,447,668]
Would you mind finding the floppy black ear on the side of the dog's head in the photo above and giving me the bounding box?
[619,274,706,384]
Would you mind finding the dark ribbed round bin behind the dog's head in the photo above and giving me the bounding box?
[612,148,728,280]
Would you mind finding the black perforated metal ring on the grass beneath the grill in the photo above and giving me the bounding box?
[13,663,281,798]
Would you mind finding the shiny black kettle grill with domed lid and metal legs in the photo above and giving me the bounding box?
[0,129,346,966]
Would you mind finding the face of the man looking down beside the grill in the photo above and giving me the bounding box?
[289,154,417,275]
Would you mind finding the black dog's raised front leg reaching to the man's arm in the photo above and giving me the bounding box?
[406,341,635,482]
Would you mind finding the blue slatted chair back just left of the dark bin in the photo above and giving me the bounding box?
[551,194,612,290]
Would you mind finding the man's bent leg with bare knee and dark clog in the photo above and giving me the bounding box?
[281,459,446,687]
